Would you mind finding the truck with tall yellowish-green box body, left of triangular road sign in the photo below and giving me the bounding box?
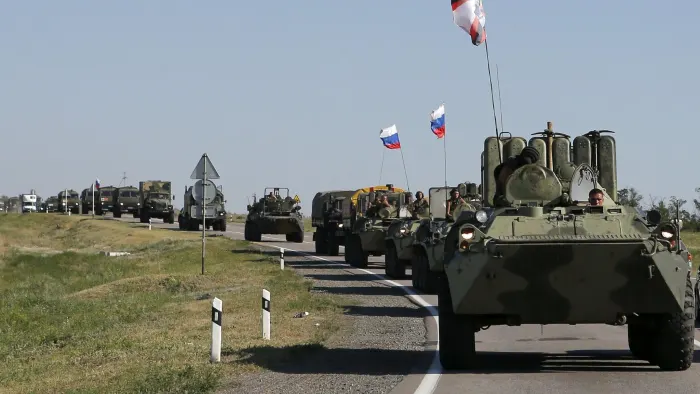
[138,180,175,224]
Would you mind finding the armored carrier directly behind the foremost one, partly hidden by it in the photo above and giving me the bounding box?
[411,182,481,294]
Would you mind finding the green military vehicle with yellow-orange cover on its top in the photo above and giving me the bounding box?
[343,184,411,268]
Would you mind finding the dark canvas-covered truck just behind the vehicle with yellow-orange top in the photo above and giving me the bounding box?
[311,189,363,256]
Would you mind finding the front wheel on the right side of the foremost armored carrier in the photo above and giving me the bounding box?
[648,278,696,371]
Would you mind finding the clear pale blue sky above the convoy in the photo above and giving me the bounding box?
[0,0,700,215]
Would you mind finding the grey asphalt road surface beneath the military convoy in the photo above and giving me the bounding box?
[112,219,700,394]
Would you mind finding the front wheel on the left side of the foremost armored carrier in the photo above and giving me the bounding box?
[438,272,476,370]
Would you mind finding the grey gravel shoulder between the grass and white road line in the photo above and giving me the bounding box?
[218,249,433,394]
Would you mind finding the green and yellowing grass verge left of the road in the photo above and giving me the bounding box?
[0,214,343,393]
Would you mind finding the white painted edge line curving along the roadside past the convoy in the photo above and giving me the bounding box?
[227,231,442,394]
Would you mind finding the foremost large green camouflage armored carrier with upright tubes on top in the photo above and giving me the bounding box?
[437,123,696,371]
